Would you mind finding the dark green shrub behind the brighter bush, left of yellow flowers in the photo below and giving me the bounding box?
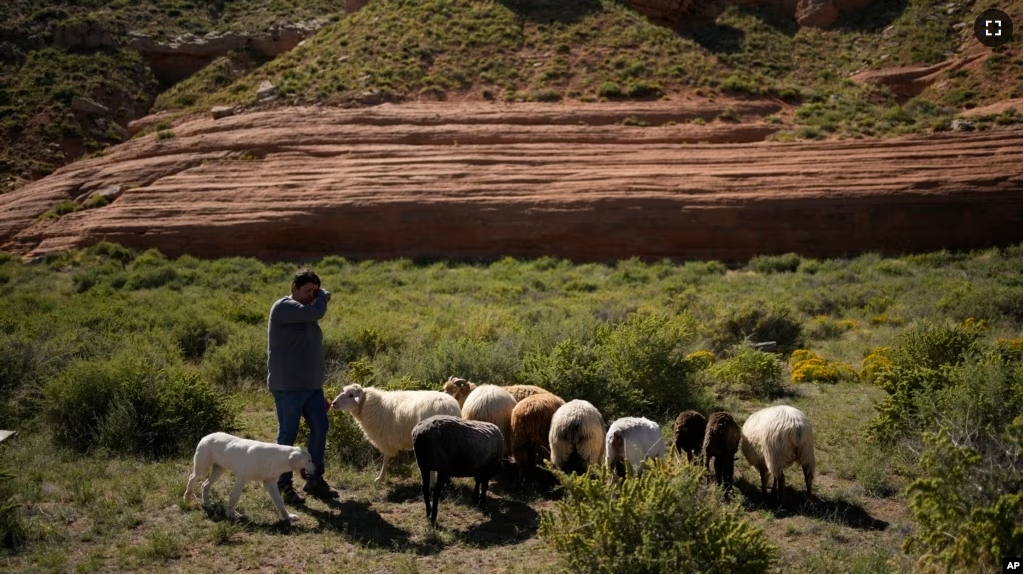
[711,303,803,353]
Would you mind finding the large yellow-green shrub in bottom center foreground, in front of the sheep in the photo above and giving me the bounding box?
[540,460,776,573]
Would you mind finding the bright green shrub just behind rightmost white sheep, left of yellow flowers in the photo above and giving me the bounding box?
[706,346,782,399]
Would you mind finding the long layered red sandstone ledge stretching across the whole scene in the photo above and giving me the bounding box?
[0,101,1024,260]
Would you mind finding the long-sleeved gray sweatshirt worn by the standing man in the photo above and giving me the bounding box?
[266,290,330,391]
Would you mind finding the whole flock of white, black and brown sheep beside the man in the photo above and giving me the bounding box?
[331,375,814,524]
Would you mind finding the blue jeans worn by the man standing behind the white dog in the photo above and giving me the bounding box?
[271,389,330,488]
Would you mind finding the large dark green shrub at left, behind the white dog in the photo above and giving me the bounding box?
[43,350,234,456]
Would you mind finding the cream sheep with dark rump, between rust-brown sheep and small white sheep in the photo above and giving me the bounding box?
[548,399,604,475]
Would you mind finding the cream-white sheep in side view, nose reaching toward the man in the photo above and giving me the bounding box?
[331,384,460,481]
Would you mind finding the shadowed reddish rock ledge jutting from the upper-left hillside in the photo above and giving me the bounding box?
[127,19,327,84]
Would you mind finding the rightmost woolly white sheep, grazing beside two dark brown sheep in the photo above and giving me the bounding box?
[739,405,814,501]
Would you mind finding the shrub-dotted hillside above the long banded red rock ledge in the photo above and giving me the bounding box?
[0,0,1022,192]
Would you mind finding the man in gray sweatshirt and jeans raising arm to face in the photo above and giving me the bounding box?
[266,269,338,499]
